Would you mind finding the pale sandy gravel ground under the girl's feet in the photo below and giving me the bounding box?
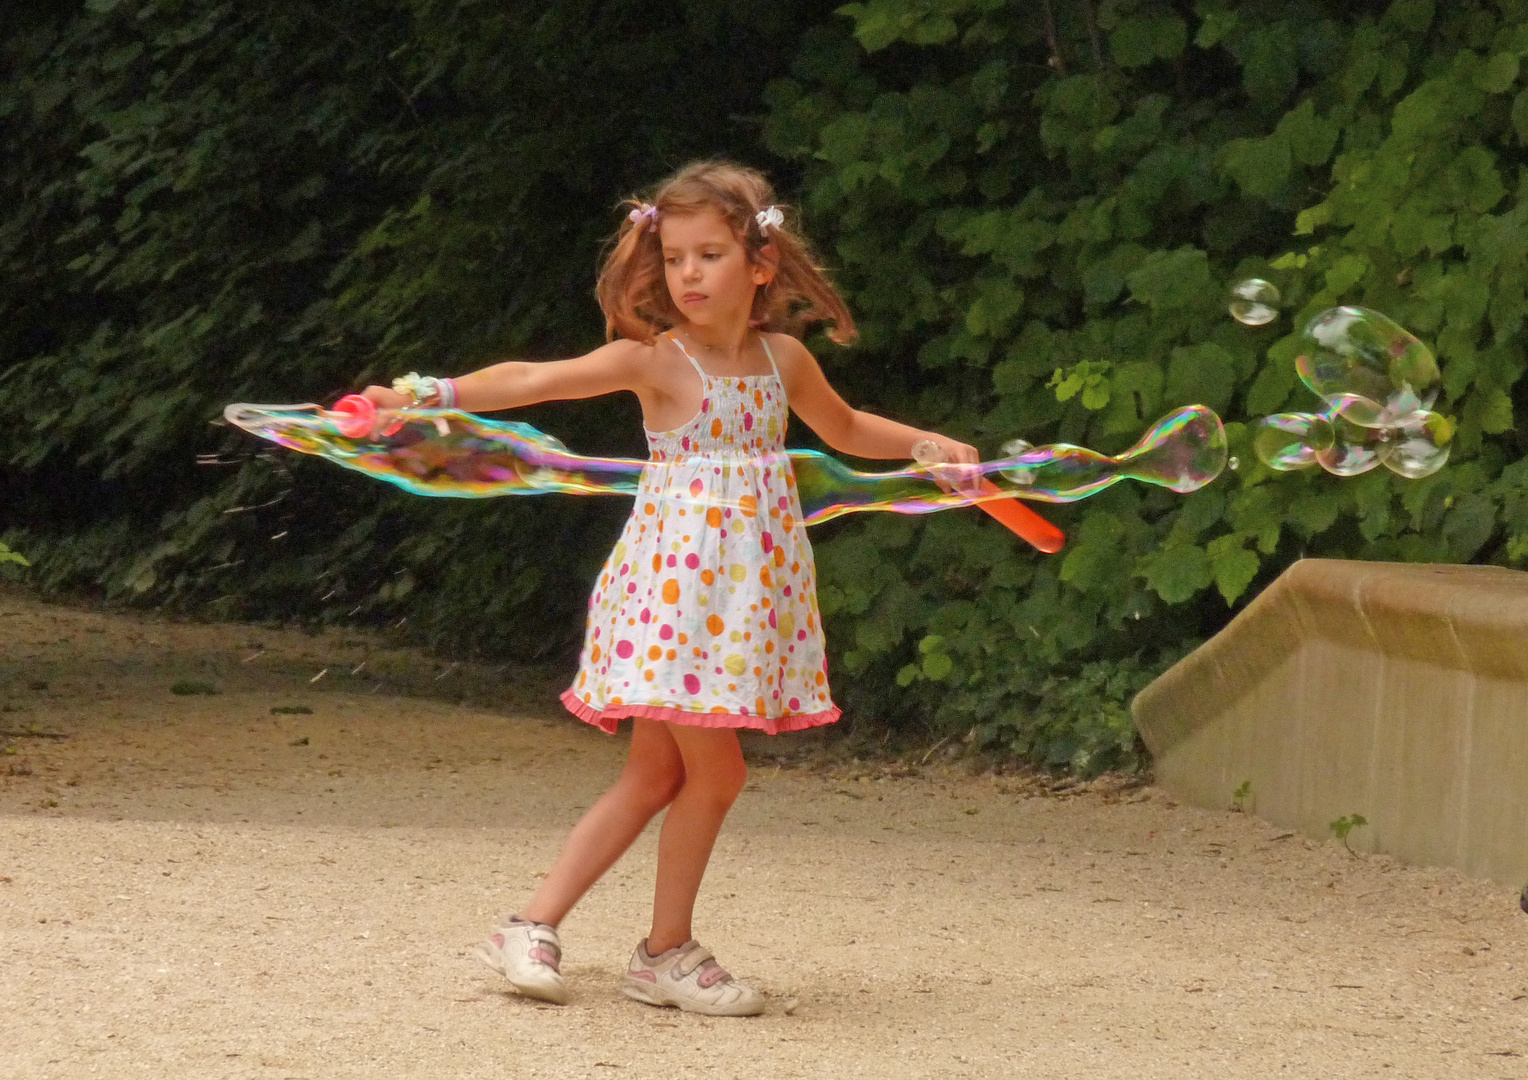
[0,591,1528,1080]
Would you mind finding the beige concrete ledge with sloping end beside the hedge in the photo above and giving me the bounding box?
[1132,559,1528,886]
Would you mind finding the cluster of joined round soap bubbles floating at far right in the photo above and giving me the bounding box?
[1253,307,1453,480]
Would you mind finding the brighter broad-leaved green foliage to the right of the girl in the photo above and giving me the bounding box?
[766,0,1528,767]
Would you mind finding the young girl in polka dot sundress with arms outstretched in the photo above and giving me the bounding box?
[365,162,978,1016]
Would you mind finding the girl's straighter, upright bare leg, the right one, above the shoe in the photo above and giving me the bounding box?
[648,724,747,955]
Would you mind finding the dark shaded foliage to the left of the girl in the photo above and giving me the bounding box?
[0,0,819,660]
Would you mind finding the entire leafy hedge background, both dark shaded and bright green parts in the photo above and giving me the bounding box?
[0,0,1528,771]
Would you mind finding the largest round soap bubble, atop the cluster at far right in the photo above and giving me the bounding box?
[1294,307,1439,428]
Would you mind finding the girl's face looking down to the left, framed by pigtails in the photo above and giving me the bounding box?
[659,208,773,330]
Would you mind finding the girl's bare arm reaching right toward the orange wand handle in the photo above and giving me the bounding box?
[769,335,981,464]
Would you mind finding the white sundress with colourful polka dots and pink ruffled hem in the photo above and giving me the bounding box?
[562,335,839,735]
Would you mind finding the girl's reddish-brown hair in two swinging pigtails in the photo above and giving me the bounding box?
[594,160,857,345]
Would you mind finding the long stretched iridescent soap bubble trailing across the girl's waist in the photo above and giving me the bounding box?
[225,405,1227,525]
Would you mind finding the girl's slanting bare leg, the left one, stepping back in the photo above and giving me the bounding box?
[520,719,684,926]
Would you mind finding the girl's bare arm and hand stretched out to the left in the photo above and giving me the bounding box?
[364,339,652,412]
